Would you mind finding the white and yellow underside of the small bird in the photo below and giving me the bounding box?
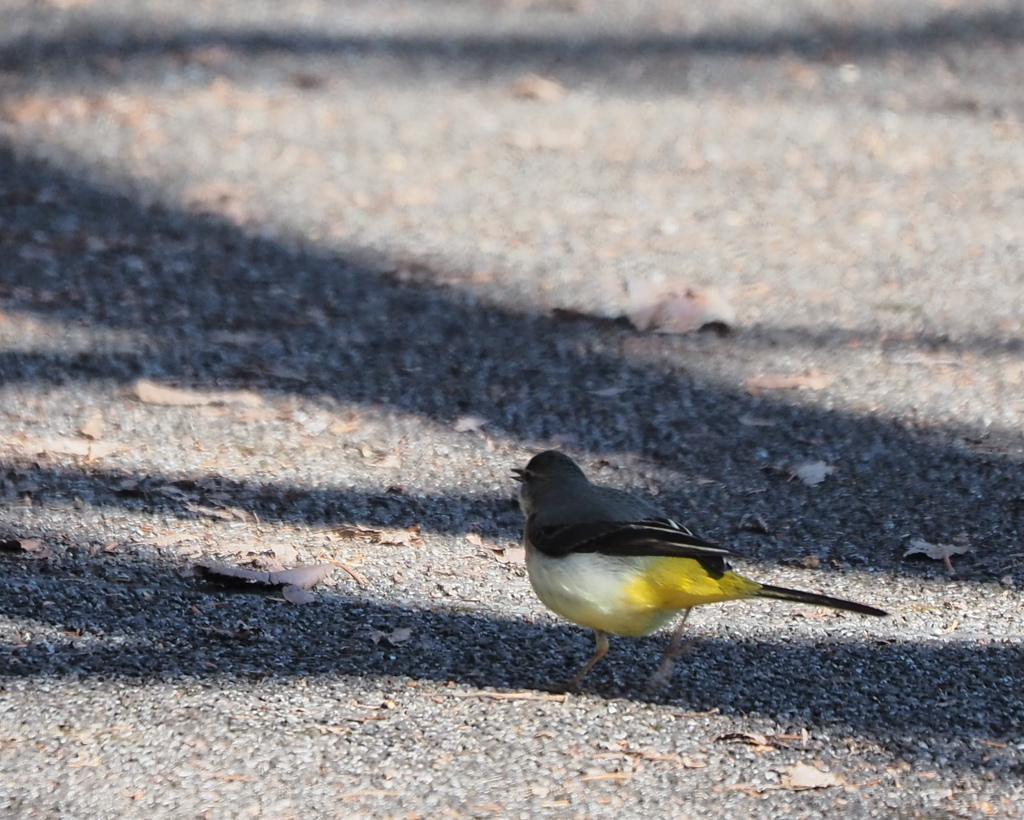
[526,550,759,637]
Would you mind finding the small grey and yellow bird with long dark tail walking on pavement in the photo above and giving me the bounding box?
[512,450,887,689]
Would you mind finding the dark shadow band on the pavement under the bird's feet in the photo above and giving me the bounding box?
[0,548,1024,769]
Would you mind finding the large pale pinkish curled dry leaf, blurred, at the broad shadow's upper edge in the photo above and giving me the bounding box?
[627,284,736,333]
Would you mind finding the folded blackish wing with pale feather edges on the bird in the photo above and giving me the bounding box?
[526,518,735,572]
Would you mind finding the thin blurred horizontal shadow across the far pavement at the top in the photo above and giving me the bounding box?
[0,8,1024,84]
